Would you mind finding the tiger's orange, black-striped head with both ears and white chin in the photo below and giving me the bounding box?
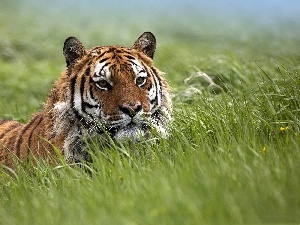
[63,32,171,140]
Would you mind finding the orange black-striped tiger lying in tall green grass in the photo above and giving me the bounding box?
[0,32,172,167]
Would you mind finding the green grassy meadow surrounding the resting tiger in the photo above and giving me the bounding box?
[0,0,300,225]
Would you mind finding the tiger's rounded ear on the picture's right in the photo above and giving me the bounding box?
[132,32,156,59]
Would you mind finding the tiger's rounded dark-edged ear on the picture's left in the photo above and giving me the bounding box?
[63,37,86,66]
